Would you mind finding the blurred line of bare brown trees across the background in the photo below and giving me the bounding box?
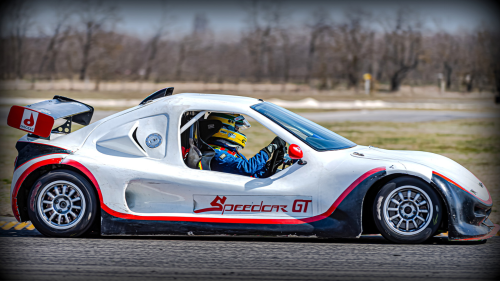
[0,0,500,92]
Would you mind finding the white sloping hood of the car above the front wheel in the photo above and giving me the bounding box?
[356,147,490,201]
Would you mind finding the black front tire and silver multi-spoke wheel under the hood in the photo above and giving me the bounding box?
[373,177,444,243]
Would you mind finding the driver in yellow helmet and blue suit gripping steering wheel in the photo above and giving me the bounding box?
[208,113,286,178]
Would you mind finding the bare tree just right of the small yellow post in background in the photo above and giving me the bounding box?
[383,8,422,91]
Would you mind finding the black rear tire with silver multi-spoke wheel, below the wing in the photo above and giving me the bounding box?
[28,170,99,237]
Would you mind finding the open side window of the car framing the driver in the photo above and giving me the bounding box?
[180,112,290,177]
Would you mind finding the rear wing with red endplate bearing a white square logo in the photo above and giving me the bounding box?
[7,96,94,138]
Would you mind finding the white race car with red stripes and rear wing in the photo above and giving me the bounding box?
[8,88,499,243]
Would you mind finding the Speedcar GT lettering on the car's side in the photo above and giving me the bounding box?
[194,195,312,215]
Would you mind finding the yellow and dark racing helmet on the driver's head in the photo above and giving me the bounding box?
[207,113,250,149]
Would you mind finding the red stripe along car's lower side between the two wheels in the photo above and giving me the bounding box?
[61,159,385,224]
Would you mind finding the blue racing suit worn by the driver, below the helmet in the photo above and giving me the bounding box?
[210,142,269,178]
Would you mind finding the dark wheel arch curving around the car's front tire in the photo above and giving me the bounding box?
[361,173,449,234]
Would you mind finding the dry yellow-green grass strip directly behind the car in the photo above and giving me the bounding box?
[0,115,500,223]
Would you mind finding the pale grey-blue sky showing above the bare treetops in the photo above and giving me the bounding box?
[33,0,498,39]
